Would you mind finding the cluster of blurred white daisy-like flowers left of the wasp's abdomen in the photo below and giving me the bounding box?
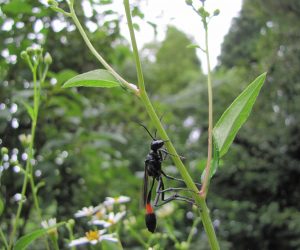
[69,196,130,247]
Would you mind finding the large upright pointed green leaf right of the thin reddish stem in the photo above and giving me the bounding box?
[213,73,266,158]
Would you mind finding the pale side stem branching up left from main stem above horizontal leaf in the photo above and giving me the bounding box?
[69,4,139,95]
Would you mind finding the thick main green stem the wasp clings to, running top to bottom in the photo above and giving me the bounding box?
[124,0,220,250]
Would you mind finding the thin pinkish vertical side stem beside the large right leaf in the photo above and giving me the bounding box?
[200,17,213,198]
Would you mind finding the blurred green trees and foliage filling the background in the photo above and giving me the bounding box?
[0,0,300,249]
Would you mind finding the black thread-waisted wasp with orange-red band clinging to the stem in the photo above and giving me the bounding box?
[140,124,200,233]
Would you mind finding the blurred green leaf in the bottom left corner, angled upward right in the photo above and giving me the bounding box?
[14,222,65,250]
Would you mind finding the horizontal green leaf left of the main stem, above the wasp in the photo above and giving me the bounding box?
[63,69,120,88]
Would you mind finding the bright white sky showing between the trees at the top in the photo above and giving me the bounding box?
[115,0,242,72]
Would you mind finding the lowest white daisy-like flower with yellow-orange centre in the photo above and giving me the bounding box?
[69,229,118,247]
